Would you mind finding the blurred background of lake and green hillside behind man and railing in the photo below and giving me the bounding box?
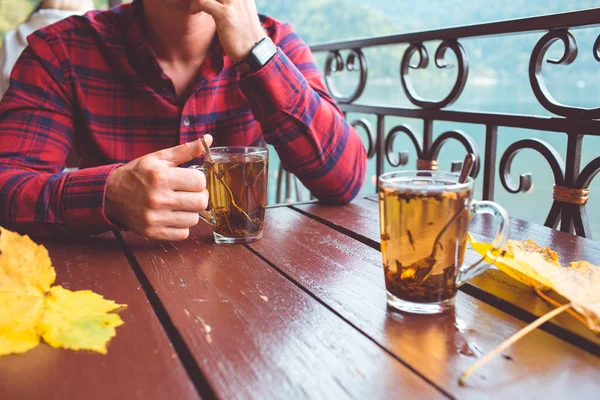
[0,0,600,238]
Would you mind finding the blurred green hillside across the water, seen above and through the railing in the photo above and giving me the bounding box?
[257,0,600,86]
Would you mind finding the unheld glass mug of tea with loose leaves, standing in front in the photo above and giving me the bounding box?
[379,171,510,314]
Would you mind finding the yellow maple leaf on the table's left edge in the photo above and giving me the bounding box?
[0,227,124,356]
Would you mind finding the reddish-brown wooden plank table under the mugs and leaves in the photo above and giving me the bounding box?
[0,198,600,400]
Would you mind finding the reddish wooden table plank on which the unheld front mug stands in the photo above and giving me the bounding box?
[250,207,600,399]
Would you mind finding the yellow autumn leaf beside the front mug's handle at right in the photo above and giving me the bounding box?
[469,236,600,334]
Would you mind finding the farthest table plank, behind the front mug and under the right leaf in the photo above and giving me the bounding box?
[294,197,600,354]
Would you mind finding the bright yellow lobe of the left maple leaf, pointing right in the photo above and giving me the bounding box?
[39,286,123,354]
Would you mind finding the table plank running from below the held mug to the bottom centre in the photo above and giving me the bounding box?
[119,226,444,399]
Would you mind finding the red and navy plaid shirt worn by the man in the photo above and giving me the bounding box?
[0,0,366,234]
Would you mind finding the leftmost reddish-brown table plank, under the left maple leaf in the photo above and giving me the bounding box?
[0,234,199,400]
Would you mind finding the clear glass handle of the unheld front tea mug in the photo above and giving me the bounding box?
[456,201,510,286]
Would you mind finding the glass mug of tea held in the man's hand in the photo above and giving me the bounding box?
[190,146,269,243]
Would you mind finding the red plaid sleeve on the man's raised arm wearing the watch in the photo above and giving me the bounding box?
[240,25,367,203]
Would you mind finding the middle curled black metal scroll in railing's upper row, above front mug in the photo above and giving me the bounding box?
[400,40,469,109]
